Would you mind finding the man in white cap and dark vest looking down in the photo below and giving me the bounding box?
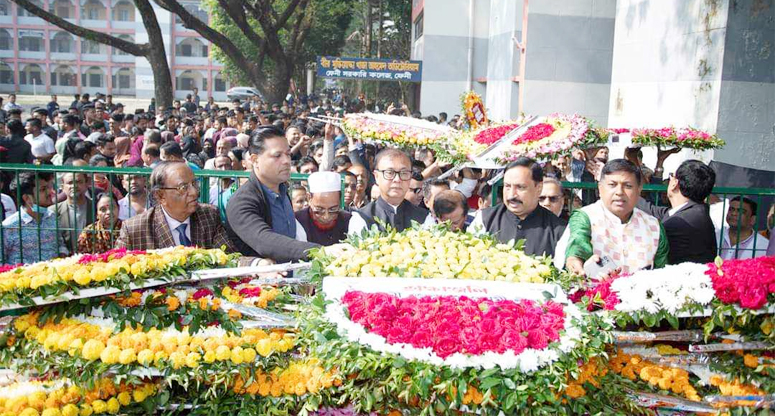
[296,172,366,246]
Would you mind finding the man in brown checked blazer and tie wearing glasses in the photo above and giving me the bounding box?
[116,161,255,265]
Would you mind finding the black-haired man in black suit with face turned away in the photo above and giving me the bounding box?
[637,160,718,264]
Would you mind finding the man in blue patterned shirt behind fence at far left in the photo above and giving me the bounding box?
[3,172,67,264]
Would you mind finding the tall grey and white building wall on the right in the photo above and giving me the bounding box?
[412,0,775,176]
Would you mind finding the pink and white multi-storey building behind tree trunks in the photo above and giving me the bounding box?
[0,0,230,100]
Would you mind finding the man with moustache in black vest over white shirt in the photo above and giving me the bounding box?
[468,157,565,256]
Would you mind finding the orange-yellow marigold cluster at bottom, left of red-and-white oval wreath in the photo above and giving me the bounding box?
[233,359,342,397]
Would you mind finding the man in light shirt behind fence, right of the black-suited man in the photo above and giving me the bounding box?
[720,196,769,260]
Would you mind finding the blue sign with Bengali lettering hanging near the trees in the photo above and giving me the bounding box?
[317,56,422,82]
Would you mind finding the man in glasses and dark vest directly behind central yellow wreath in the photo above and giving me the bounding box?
[358,148,428,232]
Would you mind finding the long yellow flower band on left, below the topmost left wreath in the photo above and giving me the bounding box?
[14,315,295,369]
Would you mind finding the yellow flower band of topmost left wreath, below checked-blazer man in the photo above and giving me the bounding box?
[0,247,229,293]
